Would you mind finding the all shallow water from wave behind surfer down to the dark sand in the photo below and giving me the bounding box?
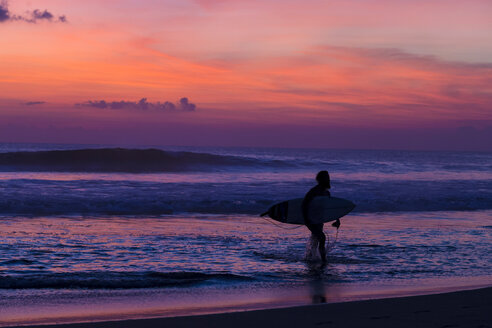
[0,211,492,325]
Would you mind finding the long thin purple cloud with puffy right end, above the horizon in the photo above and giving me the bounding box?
[75,98,196,112]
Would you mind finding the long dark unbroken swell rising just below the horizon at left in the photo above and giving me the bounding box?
[0,148,292,173]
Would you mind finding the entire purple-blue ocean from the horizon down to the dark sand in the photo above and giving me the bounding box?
[0,144,492,326]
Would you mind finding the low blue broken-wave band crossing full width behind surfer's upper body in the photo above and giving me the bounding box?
[0,179,492,216]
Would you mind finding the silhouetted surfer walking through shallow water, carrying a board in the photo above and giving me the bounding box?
[302,171,340,262]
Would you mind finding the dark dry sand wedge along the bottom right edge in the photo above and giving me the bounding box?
[12,287,492,328]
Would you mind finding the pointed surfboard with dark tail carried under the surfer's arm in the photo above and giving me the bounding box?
[262,196,355,224]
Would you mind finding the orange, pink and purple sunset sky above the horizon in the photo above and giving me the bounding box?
[0,0,492,151]
